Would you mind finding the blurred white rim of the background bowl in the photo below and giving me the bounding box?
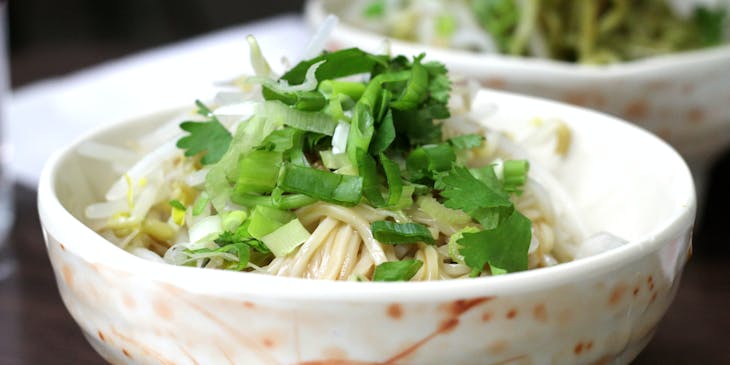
[304,0,730,80]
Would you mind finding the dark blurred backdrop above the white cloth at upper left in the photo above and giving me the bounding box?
[8,0,304,87]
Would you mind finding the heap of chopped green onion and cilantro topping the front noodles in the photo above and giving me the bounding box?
[170,44,531,281]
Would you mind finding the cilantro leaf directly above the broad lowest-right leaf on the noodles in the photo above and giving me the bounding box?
[438,166,514,229]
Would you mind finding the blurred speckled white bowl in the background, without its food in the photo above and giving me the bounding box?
[305,0,730,190]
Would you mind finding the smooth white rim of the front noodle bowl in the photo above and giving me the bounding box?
[38,89,697,302]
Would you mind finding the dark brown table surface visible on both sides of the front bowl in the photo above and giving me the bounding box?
[0,180,730,365]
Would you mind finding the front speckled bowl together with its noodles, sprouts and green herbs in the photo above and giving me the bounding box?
[39,45,696,365]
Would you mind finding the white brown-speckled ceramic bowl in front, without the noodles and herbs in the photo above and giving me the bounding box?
[38,91,696,365]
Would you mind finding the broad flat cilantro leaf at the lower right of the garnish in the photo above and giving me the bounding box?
[457,210,532,272]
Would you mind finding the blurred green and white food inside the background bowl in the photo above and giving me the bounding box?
[344,0,730,64]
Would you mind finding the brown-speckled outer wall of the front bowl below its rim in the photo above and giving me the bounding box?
[48,232,688,365]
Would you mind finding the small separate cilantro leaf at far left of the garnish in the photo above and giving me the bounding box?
[176,100,233,165]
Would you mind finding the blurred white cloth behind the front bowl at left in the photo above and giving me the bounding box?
[8,15,310,186]
